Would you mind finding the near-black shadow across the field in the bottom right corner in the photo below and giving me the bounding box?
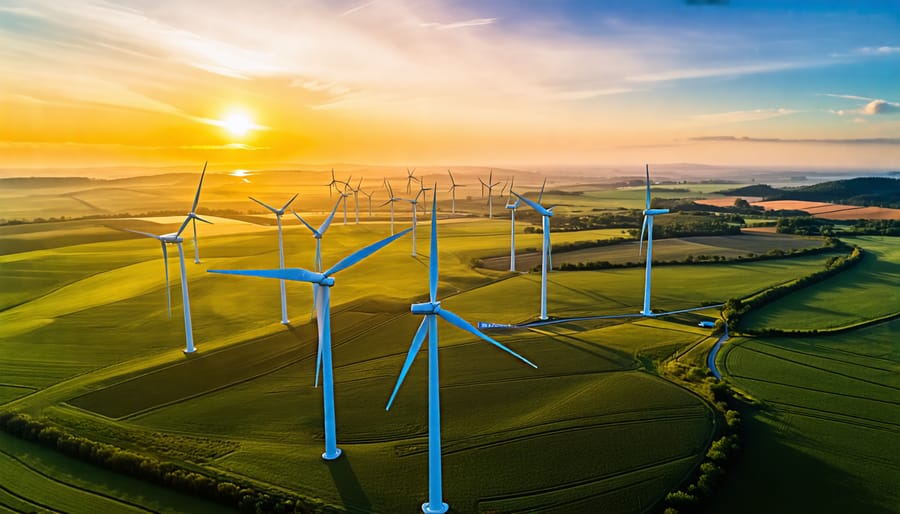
[707,407,895,514]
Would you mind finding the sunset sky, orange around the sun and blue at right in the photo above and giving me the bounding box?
[0,0,900,169]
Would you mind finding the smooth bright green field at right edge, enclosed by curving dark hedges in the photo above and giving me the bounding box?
[742,236,900,330]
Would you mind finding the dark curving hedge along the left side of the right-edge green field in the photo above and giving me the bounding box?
[722,246,865,335]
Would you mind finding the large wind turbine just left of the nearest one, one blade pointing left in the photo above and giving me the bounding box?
[208,229,411,460]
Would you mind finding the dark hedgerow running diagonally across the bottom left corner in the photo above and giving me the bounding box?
[0,412,341,514]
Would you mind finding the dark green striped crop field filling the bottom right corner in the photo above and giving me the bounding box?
[714,321,900,513]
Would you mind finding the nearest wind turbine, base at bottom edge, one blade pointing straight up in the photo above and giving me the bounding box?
[385,192,537,514]
